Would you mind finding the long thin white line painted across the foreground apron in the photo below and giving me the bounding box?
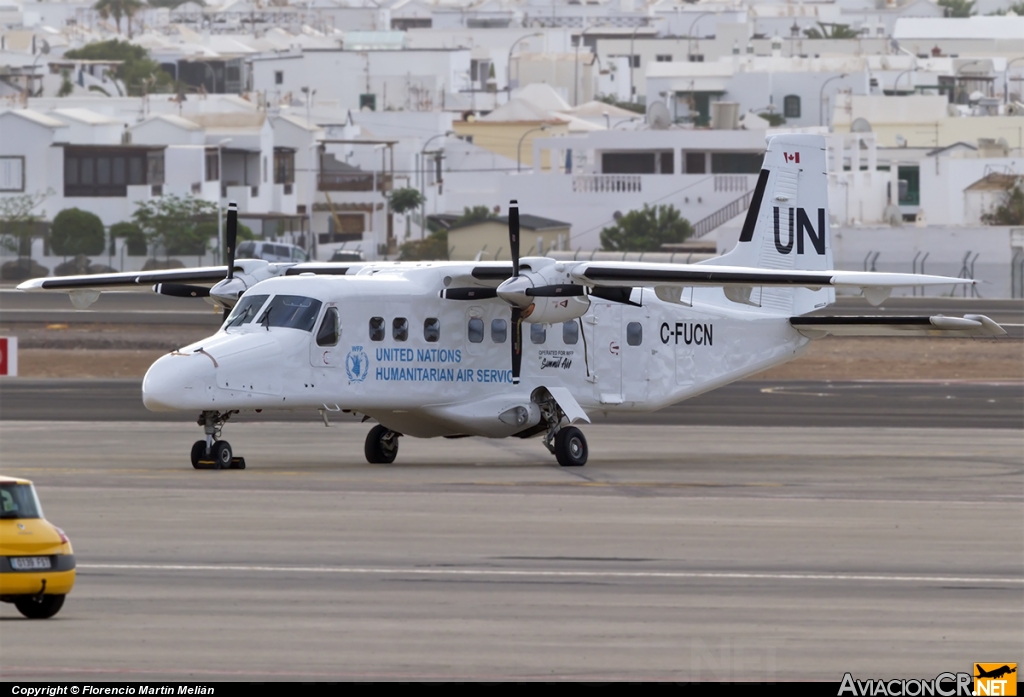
[78,564,1024,584]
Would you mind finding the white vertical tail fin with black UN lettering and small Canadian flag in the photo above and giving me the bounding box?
[703,133,836,315]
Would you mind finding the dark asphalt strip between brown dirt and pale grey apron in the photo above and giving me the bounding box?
[0,378,1024,429]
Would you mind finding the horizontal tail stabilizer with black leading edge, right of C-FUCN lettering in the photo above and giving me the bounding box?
[790,314,1007,339]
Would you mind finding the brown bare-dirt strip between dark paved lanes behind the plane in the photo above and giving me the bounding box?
[6,324,1024,380]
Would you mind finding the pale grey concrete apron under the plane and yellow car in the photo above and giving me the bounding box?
[0,420,1024,682]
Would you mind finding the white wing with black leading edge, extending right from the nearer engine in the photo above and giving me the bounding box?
[570,261,976,289]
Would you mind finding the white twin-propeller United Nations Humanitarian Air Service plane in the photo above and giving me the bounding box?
[18,134,1005,469]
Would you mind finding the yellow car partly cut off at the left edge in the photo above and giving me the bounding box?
[0,476,75,619]
